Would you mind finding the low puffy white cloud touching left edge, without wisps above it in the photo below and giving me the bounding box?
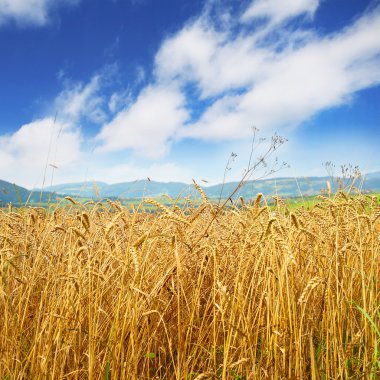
[0,118,81,187]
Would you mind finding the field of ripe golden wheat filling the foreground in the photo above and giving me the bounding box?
[0,193,380,380]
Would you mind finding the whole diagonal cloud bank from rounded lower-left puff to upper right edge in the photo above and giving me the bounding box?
[93,0,380,163]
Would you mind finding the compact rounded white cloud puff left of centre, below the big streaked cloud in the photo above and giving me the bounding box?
[97,86,188,158]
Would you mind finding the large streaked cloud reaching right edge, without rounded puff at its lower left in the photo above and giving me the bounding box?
[152,1,380,140]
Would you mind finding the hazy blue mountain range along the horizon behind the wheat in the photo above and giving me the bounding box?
[0,171,380,206]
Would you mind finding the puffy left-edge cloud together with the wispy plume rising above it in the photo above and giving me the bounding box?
[0,70,109,187]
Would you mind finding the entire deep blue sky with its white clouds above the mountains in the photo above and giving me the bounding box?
[0,0,380,188]
